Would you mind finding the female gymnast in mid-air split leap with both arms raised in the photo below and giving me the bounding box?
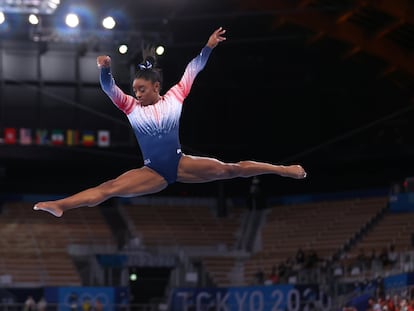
[33,27,306,217]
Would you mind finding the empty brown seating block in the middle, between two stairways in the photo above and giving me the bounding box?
[124,205,242,248]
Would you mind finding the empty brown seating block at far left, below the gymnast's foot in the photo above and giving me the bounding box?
[0,203,114,286]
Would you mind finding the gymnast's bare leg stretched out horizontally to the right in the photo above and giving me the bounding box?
[177,155,306,183]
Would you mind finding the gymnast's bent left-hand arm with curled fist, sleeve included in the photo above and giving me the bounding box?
[96,55,137,114]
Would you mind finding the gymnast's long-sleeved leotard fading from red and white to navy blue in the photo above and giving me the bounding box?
[100,46,211,184]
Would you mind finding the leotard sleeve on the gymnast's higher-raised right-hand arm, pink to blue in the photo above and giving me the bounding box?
[170,46,212,102]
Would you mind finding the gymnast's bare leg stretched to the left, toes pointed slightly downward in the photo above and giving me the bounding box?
[33,166,168,217]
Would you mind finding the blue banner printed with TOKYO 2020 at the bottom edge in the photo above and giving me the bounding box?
[171,285,332,311]
